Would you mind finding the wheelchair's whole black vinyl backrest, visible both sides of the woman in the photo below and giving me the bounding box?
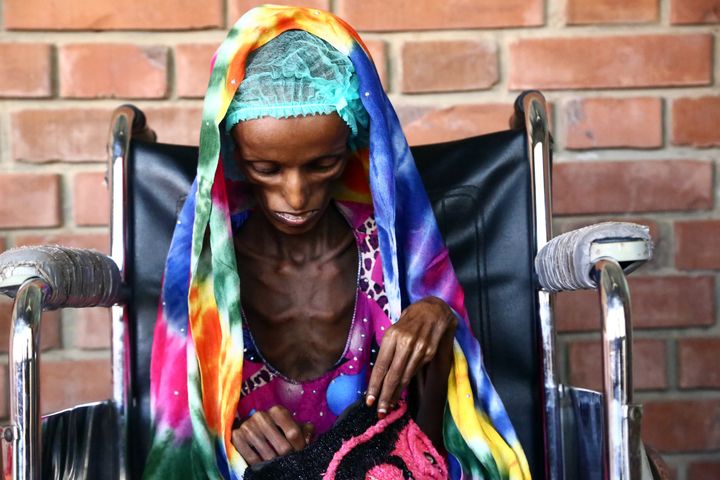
[127,131,544,478]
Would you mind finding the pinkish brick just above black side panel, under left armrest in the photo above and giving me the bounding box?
[40,358,112,413]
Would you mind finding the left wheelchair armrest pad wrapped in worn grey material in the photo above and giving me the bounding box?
[0,246,122,310]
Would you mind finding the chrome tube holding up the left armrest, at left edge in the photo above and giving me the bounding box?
[9,278,49,480]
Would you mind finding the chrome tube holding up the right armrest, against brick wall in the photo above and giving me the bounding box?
[594,258,642,480]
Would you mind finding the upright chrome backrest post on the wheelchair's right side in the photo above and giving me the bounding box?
[523,92,564,480]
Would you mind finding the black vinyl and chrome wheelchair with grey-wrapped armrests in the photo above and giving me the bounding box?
[0,91,665,480]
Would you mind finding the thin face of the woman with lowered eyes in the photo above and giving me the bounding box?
[231,114,350,235]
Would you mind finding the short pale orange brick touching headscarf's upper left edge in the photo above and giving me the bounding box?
[175,43,218,98]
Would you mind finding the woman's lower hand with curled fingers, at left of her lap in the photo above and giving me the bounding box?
[232,405,315,465]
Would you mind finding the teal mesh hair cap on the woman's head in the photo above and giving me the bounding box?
[225,30,369,150]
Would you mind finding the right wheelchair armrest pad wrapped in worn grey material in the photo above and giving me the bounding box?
[535,222,653,292]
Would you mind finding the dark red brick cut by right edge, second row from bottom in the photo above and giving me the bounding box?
[642,399,720,452]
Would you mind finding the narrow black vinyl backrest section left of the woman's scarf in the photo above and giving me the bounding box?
[126,141,197,478]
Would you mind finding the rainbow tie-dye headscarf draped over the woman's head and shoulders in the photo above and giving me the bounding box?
[145,6,530,480]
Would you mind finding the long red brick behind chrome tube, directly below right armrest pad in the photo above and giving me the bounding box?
[555,276,715,332]
